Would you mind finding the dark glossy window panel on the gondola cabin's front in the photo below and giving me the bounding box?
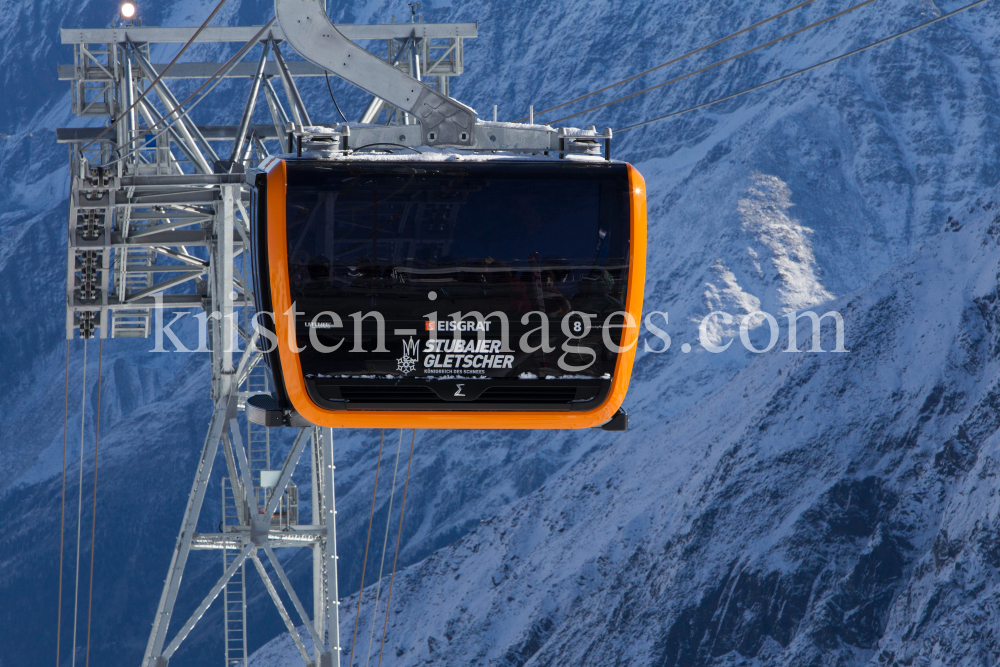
[287,161,630,377]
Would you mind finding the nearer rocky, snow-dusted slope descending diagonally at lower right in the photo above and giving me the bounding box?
[257,193,1000,667]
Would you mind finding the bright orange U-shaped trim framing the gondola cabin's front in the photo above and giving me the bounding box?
[267,159,646,429]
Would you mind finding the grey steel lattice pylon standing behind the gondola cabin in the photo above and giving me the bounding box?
[57,17,476,667]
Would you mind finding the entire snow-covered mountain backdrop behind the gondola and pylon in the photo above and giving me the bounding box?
[0,0,1000,667]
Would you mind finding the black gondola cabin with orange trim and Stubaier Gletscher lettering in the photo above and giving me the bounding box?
[247,154,646,428]
